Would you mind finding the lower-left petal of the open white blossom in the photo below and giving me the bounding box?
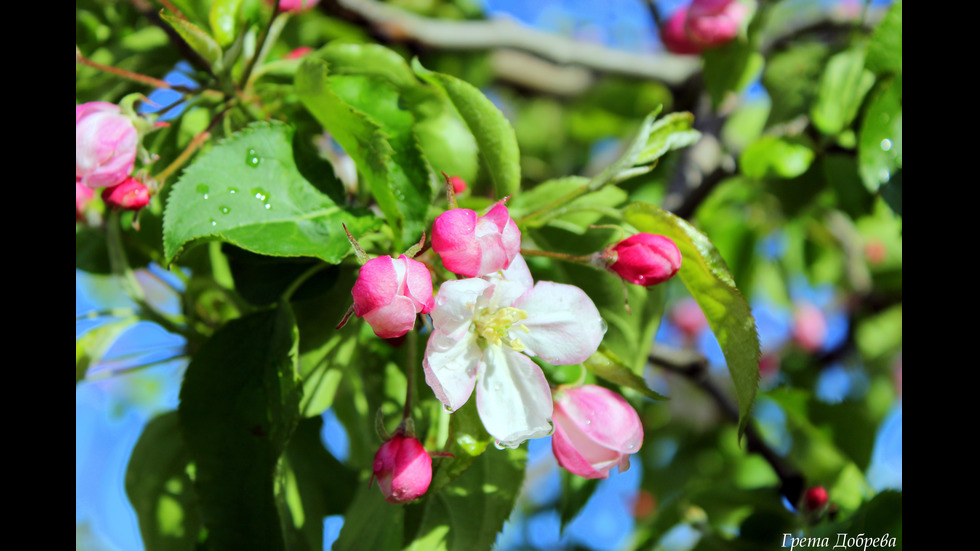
[422,330,483,411]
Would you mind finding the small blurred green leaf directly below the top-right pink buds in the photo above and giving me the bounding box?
[703,39,765,107]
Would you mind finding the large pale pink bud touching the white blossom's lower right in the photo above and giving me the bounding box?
[551,385,643,478]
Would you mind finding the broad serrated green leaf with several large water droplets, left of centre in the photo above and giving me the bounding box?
[163,123,380,264]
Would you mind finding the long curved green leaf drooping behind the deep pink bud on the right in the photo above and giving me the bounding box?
[624,203,760,436]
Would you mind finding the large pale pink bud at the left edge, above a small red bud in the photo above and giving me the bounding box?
[75,101,139,188]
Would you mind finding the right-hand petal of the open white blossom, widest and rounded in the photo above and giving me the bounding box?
[510,281,606,365]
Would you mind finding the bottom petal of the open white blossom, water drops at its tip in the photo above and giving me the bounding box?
[476,345,553,448]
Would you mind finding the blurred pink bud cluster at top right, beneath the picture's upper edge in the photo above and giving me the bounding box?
[660,0,747,54]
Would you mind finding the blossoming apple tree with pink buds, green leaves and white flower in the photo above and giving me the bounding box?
[75,0,901,550]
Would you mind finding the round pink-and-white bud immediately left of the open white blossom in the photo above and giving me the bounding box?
[351,255,434,339]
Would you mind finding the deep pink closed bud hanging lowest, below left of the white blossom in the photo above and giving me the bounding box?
[373,434,432,503]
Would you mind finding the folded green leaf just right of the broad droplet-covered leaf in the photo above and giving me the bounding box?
[296,58,435,246]
